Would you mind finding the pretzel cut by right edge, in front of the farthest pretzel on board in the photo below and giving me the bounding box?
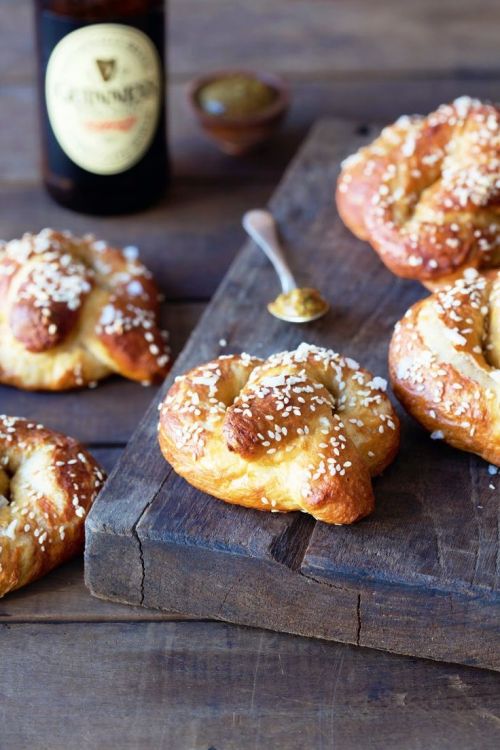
[389,269,500,465]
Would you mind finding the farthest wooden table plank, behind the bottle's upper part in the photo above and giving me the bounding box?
[0,0,500,81]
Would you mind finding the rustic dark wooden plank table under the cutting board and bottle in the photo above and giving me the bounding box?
[0,0,500,750]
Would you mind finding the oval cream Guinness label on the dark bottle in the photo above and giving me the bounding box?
[45,23,162,175]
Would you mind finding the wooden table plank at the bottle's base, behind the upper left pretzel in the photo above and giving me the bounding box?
[0,183,271,301]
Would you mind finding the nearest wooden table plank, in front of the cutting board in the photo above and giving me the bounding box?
[0,622,500,750]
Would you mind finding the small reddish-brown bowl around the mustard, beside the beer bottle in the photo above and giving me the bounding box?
[188,70,289,156]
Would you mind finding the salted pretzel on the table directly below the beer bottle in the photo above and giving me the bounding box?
[0,229,169,390]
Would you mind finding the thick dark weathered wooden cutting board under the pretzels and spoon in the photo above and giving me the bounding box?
[85,120,500,669]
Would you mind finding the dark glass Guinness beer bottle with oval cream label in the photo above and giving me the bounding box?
[35,0,168,214]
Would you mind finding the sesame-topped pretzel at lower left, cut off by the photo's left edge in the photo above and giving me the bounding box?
[0,416,104,596]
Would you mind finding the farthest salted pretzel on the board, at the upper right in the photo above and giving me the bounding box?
[336,96,500,288]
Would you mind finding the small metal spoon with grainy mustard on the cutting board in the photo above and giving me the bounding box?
[242,209,329,323]
